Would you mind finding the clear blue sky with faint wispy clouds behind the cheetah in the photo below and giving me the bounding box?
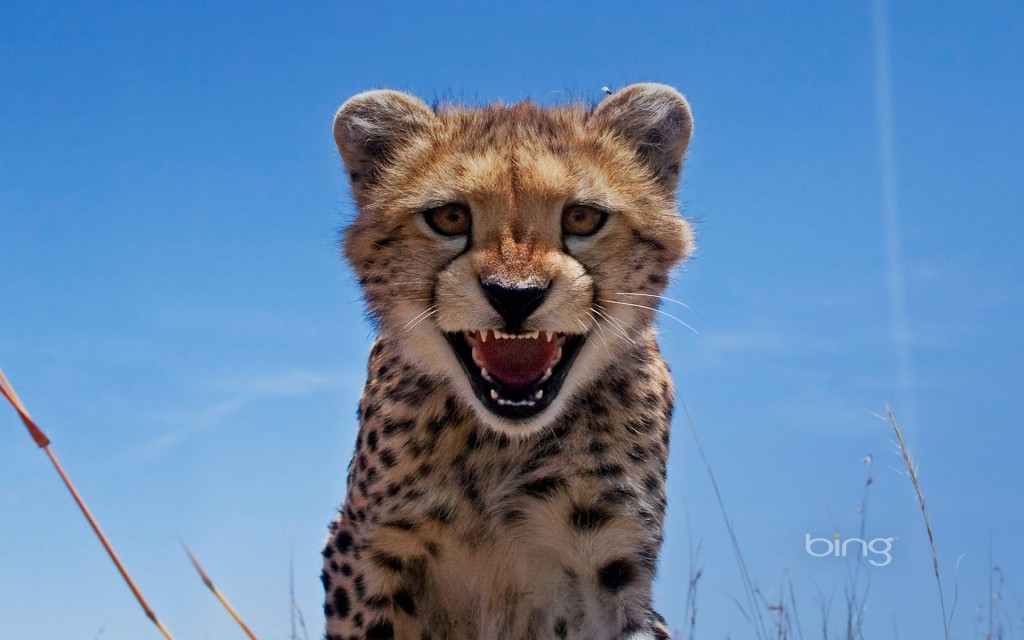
[0,2,1024,640]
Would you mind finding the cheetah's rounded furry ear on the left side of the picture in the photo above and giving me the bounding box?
[334,89,434,199]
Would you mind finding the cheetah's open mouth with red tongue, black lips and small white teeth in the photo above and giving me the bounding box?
[444,329,587,420]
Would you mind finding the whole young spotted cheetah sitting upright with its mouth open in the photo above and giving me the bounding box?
[322,83,693,640]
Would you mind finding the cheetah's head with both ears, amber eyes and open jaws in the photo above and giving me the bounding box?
[334,84,692,435]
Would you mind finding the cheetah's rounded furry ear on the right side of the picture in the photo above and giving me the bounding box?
[591,82,693,191]
